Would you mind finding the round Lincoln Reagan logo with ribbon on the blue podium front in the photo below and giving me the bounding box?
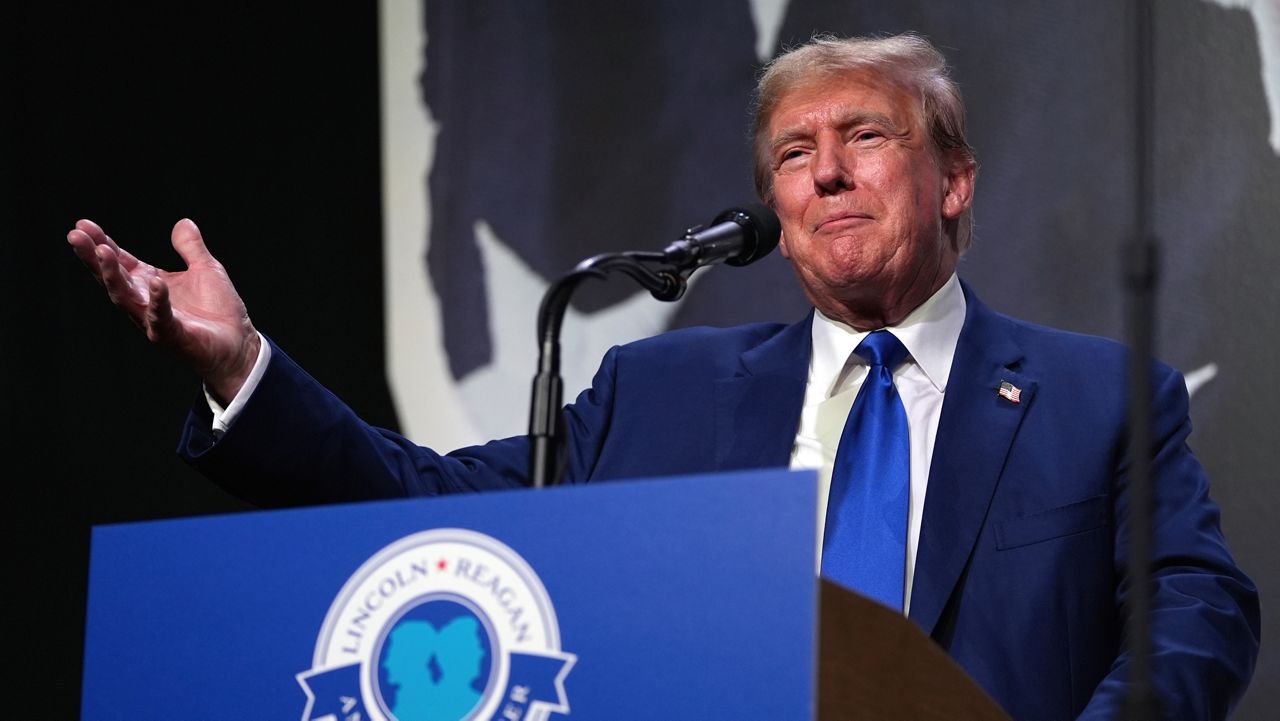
[297,529,576,721]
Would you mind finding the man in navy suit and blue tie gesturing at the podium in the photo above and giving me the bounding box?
[68,36,1258,718]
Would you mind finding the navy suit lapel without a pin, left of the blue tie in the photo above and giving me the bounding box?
[714,311,813,470]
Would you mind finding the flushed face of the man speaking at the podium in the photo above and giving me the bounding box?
[768,72,974,329]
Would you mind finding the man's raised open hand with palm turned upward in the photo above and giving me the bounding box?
[67,219,260,403]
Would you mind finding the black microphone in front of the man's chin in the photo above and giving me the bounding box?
[662,202,782,270]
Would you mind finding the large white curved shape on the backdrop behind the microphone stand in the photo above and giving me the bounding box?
[379,0,712,451]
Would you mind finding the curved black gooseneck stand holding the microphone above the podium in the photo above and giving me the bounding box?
[529,252,698,488]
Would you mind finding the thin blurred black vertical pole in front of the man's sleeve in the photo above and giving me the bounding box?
[1123,0,1161,721]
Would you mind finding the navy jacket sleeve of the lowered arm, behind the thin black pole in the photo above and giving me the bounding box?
[1080,369,1261,720]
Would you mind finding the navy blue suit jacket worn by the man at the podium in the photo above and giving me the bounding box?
[179,287,1260,720]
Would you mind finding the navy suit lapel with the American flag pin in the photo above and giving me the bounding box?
[910,286,1036,633]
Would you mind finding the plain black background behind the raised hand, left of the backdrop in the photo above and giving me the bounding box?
[11,1,396,718]
